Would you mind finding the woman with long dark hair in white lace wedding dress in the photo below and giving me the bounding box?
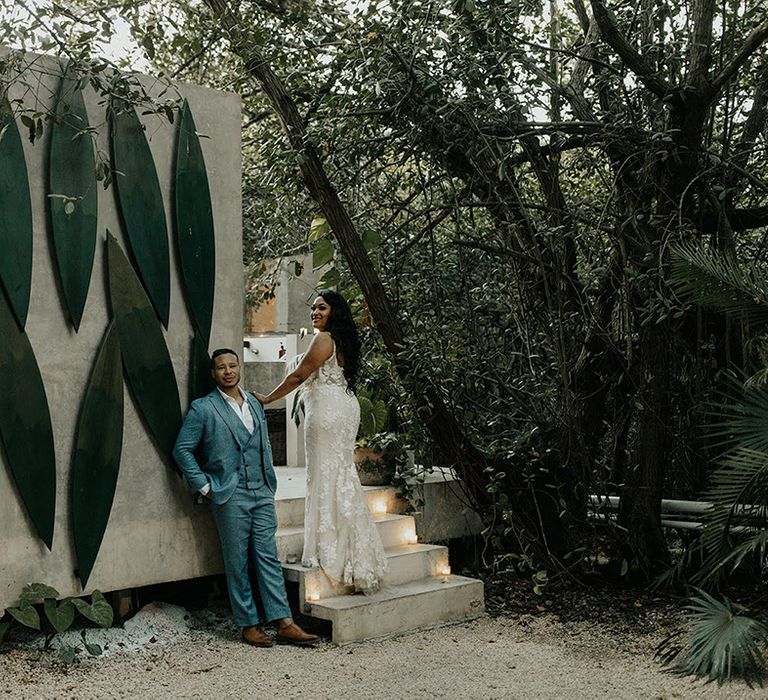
[256,290,386,592]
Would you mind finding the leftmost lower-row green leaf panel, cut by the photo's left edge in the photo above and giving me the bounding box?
[0,293,56,549]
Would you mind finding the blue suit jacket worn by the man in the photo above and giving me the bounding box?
[173,389,277,505]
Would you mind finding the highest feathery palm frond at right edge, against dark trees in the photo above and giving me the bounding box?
[669,243,768,324]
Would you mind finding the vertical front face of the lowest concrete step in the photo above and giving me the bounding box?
[309,581,484,644]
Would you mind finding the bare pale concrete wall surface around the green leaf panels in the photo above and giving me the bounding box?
[0,50,243,609]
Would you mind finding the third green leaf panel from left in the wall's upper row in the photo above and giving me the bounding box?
[110,100,171,328]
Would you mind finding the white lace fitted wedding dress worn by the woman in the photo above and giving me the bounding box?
[301,345,386,592]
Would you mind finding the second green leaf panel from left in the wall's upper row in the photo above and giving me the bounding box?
[48,64,98,330]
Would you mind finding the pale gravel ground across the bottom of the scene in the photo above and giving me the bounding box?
[0,606,768,700]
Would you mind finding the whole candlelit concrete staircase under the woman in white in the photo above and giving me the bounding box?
[277,487,485,644]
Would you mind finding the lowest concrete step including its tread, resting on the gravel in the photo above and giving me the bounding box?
[304,576,484,644]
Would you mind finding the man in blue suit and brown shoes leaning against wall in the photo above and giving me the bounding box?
[173,348,318,647]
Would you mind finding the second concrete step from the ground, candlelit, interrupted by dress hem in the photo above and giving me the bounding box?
[283,544,448,600]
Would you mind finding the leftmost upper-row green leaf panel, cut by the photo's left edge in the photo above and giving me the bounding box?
[0,100,32,328]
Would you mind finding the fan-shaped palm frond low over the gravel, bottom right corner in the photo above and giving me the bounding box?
[656,590,768,686]
